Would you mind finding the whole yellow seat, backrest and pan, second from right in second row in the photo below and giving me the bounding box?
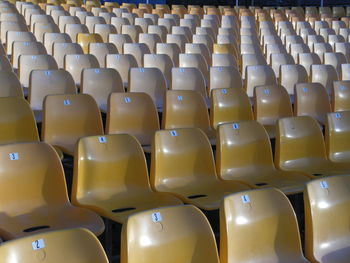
[275,116,349,176]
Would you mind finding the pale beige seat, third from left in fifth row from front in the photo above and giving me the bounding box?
[64,54,100,88]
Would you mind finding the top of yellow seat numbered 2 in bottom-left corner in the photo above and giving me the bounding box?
[0,228,108,263]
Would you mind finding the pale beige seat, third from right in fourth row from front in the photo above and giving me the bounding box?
[279,64,308,94]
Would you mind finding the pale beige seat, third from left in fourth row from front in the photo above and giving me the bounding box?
[80,68,124,112]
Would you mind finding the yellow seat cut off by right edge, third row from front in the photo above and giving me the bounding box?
[331,80,350,112]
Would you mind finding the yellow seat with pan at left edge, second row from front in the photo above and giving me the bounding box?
[0,142,104,240]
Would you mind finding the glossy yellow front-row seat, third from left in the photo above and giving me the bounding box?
[220,188,309,263]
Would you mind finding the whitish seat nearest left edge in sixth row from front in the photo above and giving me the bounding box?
[11,41,47,69]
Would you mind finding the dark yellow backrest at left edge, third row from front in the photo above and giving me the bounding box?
[0,97,39,144]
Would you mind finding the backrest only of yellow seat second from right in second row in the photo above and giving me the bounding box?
[274,116,326,169]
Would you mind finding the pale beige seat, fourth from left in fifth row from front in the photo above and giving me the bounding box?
[106,54,138,87]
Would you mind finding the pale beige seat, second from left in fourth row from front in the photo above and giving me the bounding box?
[28,69,77,122]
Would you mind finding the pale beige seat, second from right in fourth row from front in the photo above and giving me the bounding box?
[311,65,339,94]
